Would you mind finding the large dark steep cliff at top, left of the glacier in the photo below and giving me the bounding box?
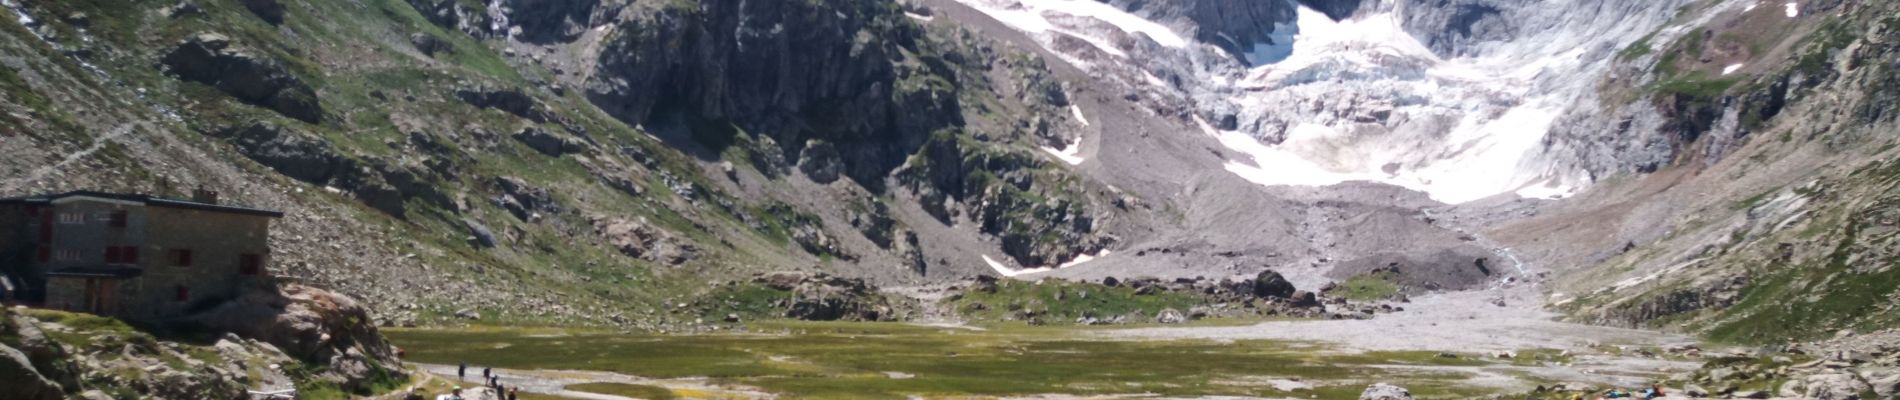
[585,0,961,188]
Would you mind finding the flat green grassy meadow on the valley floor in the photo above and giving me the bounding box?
[388,322,1503,398]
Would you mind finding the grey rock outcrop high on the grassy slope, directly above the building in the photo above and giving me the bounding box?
[162,32,323,123]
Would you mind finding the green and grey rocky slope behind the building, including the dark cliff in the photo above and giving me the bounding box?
[0,0,1123,326]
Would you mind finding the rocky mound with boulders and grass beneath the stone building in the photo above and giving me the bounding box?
[0,286,407,400]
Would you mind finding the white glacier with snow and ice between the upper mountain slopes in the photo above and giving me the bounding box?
[958,0,1694,205]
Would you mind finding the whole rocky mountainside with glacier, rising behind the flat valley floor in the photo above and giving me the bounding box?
[0,0,1894,348]
